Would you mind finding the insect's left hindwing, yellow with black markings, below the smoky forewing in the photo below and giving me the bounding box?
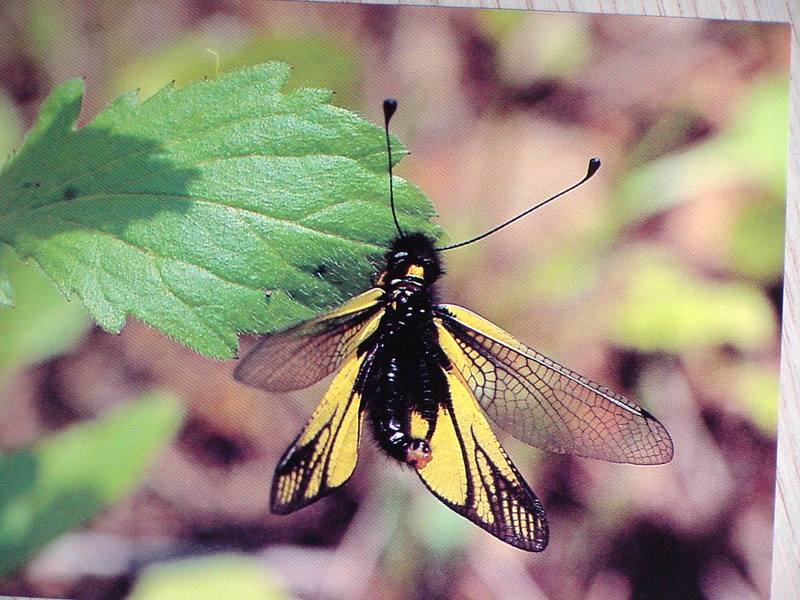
[271,354,368,514]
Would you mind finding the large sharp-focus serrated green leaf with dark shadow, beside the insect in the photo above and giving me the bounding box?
[0,63,438,358]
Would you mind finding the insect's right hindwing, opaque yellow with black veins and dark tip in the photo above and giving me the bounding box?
[417,360,548,552]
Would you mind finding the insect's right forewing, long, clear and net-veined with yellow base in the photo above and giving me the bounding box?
[436,305,673,465]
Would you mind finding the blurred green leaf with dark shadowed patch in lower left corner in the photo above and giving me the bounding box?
[0,394,183,574]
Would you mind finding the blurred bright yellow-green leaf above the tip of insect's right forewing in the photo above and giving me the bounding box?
[611,252,775,353]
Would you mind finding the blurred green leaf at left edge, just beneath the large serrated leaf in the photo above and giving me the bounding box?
[0,248,90,383]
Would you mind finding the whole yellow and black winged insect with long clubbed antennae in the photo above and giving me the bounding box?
[235,100,673,552]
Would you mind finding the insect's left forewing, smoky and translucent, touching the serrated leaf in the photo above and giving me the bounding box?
[233,288,384,392]
